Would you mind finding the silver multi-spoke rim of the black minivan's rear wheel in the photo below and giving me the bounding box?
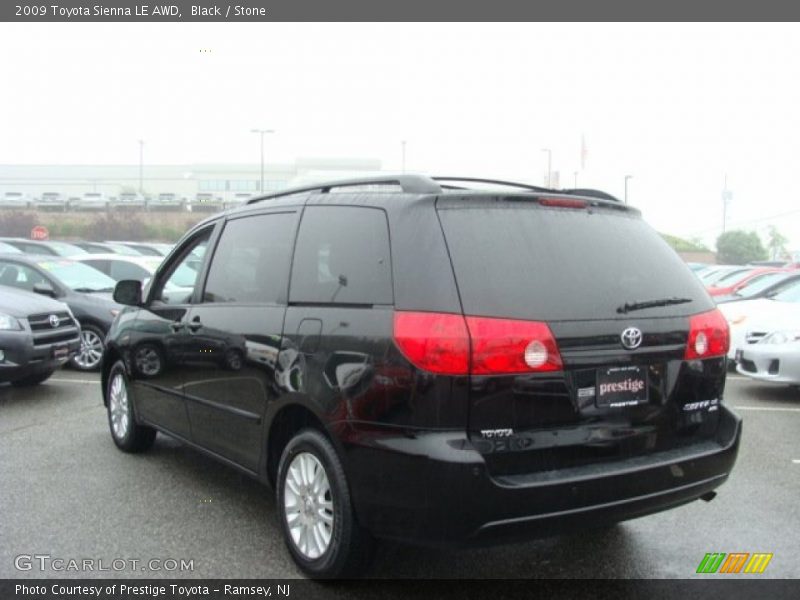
[283,452,334,559]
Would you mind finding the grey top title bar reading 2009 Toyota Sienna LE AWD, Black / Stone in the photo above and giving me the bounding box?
[0,0,800,21]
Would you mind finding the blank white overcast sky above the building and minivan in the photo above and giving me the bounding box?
[0,23,800,250]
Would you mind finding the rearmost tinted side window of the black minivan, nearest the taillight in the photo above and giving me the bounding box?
[289,206,394,305]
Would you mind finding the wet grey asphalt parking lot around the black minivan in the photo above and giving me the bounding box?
[0,371,800,578]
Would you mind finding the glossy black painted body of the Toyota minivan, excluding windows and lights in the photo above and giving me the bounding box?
[103,193,741,544]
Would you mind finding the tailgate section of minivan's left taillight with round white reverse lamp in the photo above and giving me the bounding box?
[467,317,562,375]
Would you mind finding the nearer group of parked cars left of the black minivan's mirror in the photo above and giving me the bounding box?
[0,238,178,376]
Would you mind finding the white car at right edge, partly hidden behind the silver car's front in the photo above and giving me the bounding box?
[718,283,800,359]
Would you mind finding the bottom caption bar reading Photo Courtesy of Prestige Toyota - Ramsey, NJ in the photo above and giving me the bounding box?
[0,575,800,600]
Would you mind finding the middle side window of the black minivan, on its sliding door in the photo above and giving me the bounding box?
[203,213,297,304]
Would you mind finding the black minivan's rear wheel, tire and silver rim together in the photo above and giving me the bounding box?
[276,429,374,579]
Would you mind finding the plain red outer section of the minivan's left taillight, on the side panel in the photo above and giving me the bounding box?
[394,312,469,375]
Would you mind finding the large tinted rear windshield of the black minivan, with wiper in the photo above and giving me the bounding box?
[439,202,713,321]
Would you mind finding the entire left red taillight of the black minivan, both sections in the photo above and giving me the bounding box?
[394,312,562,375]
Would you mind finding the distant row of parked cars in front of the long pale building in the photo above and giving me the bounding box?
[0,191,252,212]
